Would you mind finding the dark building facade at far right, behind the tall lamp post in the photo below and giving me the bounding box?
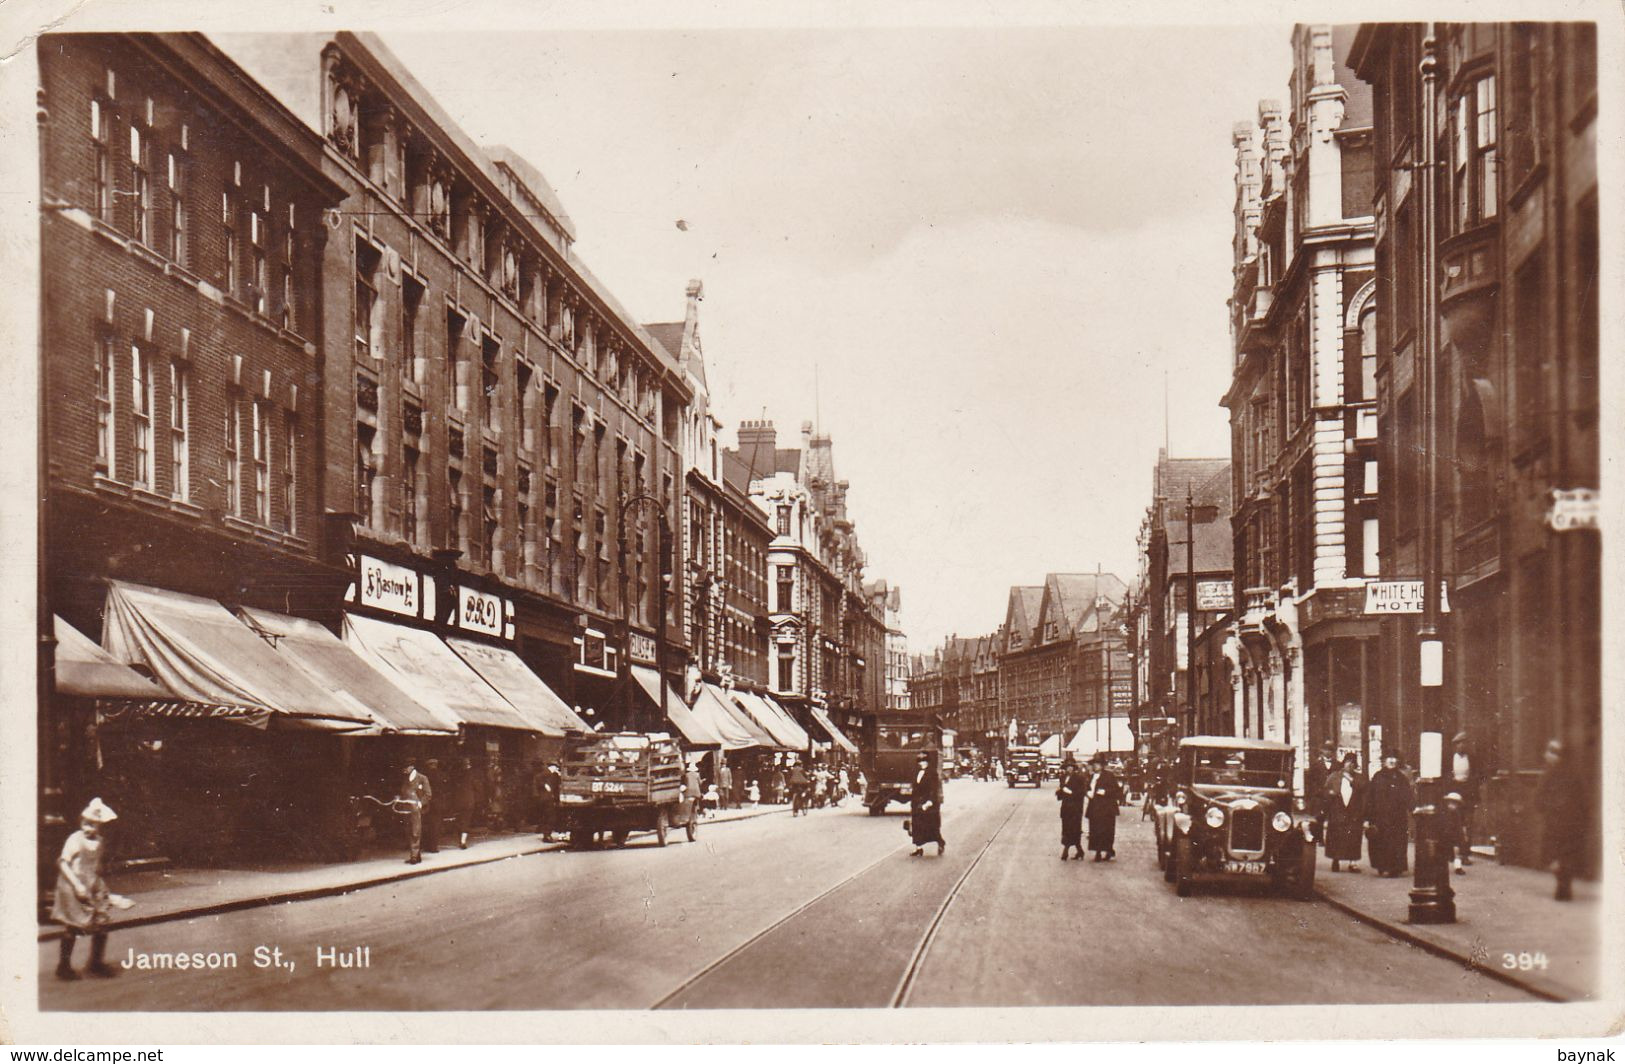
[1350,23,1602,863]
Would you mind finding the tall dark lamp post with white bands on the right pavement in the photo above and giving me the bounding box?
[1411,23,1456,924]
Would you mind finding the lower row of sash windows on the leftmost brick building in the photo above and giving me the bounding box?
[94,335,299,533]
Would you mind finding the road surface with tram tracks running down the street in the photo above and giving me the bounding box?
[39,780,1532,1010]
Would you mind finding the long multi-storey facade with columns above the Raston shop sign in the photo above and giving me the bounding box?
[231,32,691,734]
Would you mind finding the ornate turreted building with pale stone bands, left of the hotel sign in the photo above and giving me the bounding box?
[1224,24,1383,786]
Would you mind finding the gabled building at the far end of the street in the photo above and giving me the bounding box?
[998,573,1131,742]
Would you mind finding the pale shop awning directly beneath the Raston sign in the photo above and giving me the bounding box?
[345,614,531,731]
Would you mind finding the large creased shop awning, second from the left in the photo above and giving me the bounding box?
[102,580,372,726]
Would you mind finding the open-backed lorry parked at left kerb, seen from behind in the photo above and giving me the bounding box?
[559,731,699,850]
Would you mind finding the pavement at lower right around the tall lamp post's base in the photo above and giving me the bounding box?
[1315,853,1602,1001]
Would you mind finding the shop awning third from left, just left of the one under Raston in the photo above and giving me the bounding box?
[237,608,457,734]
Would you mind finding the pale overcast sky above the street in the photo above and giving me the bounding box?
[365,24,1290,650]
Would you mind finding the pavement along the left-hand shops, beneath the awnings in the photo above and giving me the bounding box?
[39,804,790,942]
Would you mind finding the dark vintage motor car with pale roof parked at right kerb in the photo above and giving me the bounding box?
[1157,736,1315,898]
